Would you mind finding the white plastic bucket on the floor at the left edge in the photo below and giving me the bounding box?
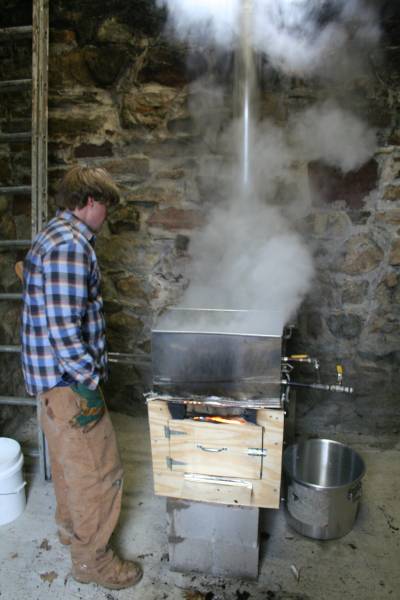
[0,437,26,525]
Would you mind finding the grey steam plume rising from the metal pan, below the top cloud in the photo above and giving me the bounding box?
[176,102,376,331]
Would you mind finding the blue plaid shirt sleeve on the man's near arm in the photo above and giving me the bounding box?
[43,241,100,389]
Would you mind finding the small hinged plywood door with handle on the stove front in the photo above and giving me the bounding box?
[168,419,263,479]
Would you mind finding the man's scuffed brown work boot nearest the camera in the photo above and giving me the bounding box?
[72,555,143,590]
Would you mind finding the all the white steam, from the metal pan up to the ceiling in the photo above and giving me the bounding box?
[157,0,379,333]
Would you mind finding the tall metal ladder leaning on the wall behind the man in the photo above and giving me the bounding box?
[0,0,51,480]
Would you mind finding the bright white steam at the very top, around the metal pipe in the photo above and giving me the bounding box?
[157,0,380,77]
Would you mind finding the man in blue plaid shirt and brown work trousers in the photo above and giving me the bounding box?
[22,166,142,589]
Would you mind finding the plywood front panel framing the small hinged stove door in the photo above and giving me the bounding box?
[148,399,284,508]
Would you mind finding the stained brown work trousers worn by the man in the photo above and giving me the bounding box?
[41,387,123,571]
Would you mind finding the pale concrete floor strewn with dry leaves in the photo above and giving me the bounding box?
[0,413,400,600]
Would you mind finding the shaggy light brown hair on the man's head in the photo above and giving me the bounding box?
[55,166,119,210]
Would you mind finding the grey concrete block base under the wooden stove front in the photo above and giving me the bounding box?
[167,498,260,578]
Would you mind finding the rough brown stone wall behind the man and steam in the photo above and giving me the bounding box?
[0,0,400,433]
